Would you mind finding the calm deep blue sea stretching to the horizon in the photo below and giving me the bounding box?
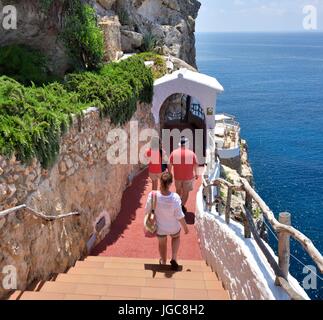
[196,33,323,299]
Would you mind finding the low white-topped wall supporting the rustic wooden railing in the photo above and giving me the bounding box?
[195,189,308,300]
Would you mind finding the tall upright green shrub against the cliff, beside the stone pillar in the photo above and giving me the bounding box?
[61,0,104,70]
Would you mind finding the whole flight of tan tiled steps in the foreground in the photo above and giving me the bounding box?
[10,257,230,300]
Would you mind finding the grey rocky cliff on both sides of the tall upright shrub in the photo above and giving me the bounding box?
[0,0,200,74]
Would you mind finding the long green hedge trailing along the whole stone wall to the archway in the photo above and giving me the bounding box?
[0,57,153,168]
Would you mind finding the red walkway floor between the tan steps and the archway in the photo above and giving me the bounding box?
[91,171,202,260]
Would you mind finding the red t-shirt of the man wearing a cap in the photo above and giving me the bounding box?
[169,148,198,181]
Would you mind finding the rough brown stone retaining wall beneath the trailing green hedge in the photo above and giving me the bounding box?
[0,104,154,298]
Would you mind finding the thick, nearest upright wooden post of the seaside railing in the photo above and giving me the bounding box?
[276,212,291,283]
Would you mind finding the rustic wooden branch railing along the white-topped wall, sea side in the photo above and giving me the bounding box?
[203,178,323,300]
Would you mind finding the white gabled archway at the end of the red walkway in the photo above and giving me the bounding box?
[152,69,224,129]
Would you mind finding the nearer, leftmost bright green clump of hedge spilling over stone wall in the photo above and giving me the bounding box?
[0,76,87,168]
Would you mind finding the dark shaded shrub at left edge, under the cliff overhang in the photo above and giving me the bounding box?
[0,44,53,85]
